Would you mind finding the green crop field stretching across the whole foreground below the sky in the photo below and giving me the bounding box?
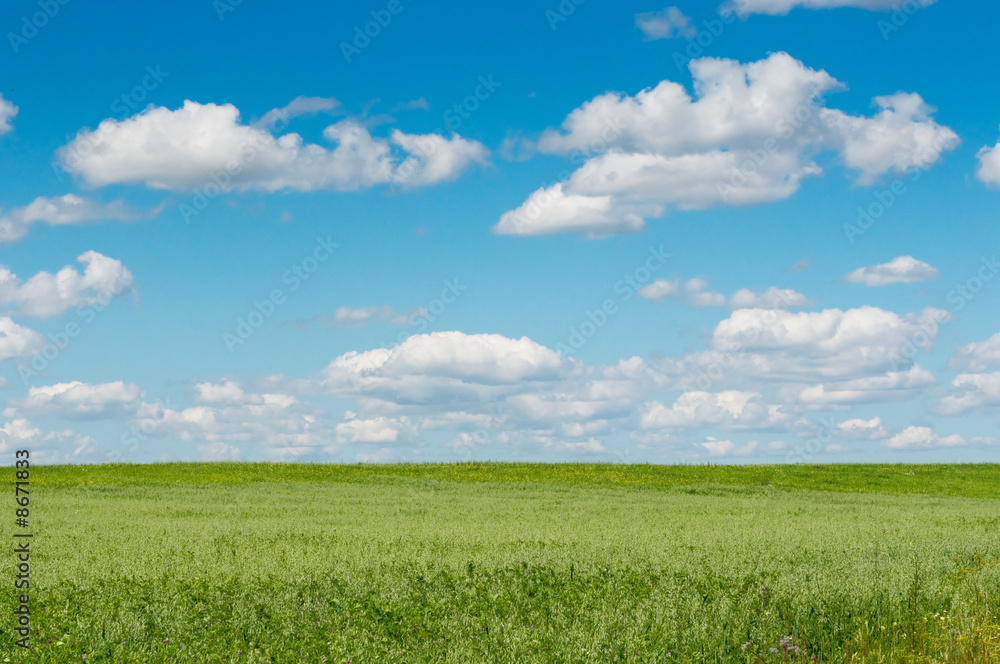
[0,464,1000,664]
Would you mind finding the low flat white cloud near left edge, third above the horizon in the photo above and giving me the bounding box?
[11,380,143,419]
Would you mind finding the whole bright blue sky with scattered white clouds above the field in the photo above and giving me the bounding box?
[0,0,1000,463]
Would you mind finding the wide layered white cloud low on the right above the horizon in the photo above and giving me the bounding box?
[650,307,948,408]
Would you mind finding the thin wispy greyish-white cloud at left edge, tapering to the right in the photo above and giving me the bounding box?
[0,194,156,244]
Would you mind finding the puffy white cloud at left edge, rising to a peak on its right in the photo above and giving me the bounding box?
[0,251,132,318]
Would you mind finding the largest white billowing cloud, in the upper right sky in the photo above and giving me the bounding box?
[494,53,958,237]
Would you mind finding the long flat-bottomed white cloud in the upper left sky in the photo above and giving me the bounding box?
[59,101,487,191]
